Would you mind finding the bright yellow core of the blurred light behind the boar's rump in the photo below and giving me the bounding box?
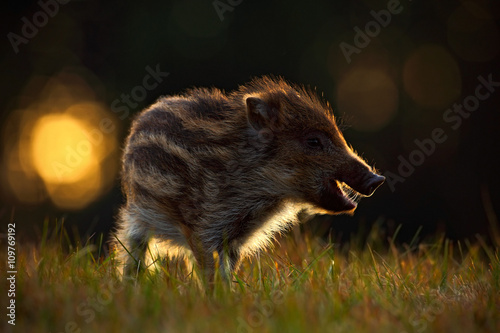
[30,111,113,208]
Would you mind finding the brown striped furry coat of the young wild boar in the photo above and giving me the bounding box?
[112,77,382,281]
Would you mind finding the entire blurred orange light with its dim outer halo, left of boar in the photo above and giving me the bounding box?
[5,71,119,209]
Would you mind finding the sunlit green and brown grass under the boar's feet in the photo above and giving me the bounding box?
[0,220,500,333]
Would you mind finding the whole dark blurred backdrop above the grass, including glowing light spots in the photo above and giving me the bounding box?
[0,0,500,241]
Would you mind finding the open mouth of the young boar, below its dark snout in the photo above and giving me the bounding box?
[320,179,359,213]
